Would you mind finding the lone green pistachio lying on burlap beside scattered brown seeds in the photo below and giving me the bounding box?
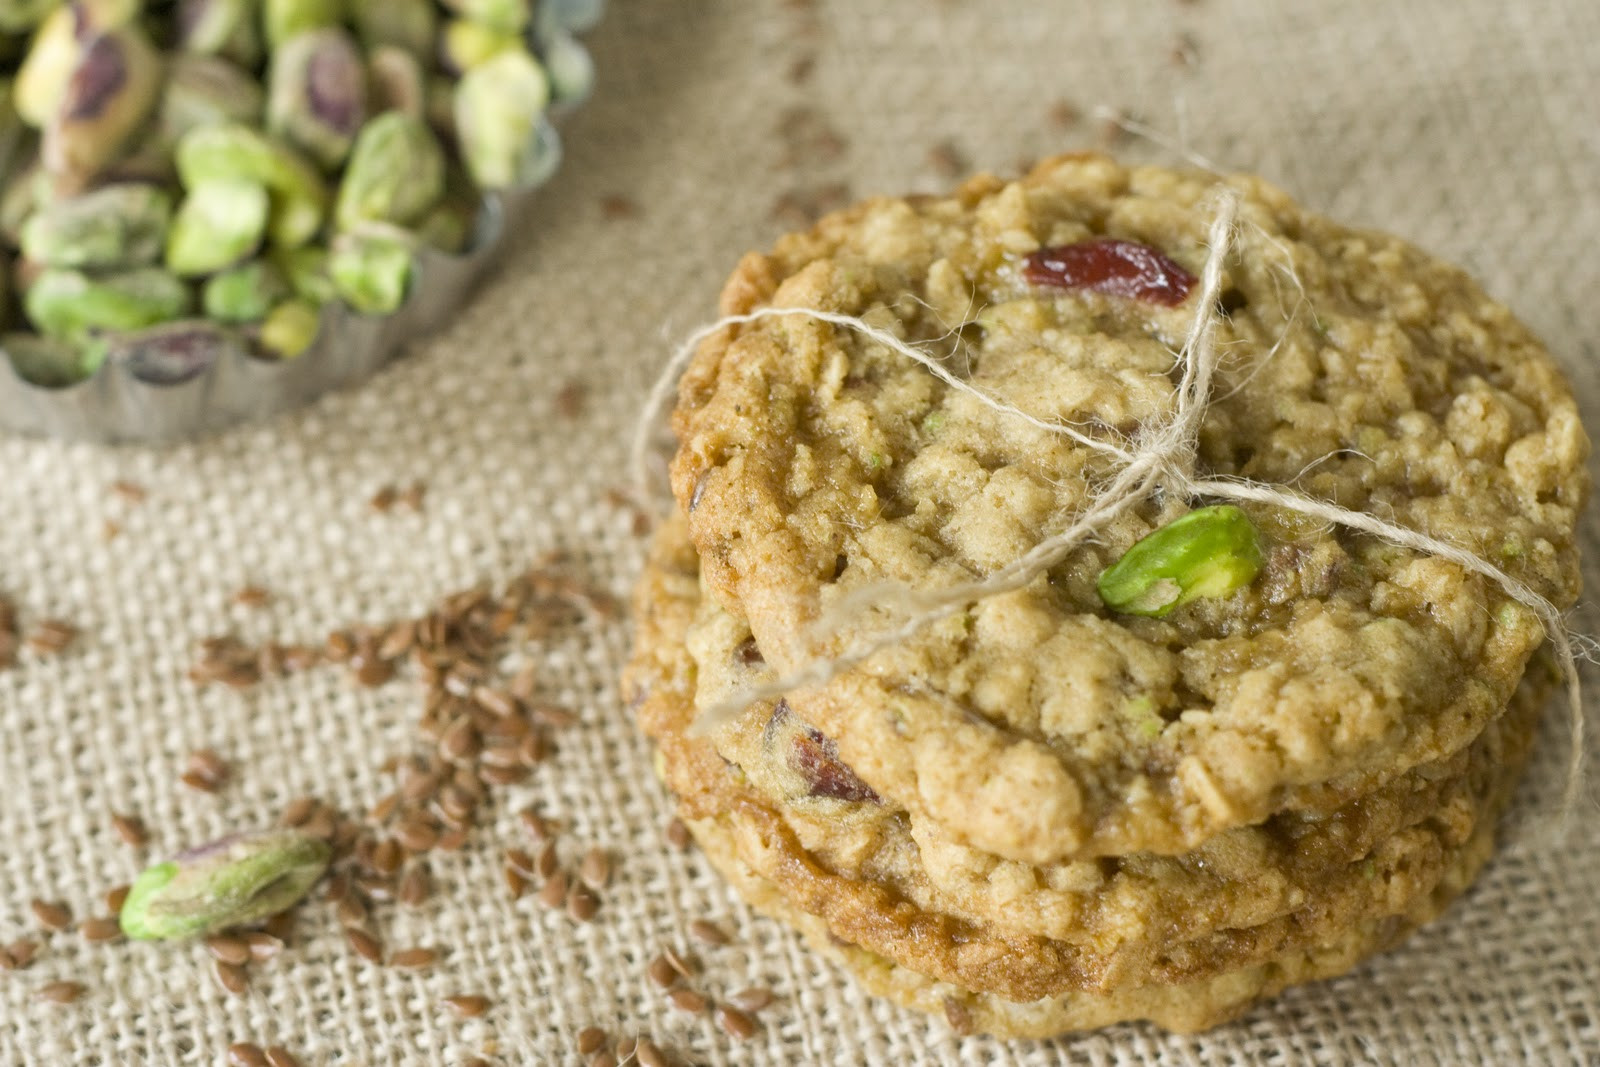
[118,830,333,941]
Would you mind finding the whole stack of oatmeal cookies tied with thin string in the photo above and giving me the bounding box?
[627,155,1587,1035]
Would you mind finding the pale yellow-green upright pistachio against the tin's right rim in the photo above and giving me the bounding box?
[456,51,550,189]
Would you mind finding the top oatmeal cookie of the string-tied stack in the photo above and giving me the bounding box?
[672,155,1587,864]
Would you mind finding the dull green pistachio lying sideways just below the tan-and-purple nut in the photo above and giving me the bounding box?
[22,184,173,269]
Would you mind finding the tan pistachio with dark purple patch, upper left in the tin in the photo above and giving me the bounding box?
[40,26,165,192]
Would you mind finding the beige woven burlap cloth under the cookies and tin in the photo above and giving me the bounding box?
[0,0,1600,1067]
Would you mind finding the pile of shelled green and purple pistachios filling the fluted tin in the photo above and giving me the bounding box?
[0,0,587,387]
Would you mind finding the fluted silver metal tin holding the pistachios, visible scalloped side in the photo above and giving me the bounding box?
[0,0,603,445]
